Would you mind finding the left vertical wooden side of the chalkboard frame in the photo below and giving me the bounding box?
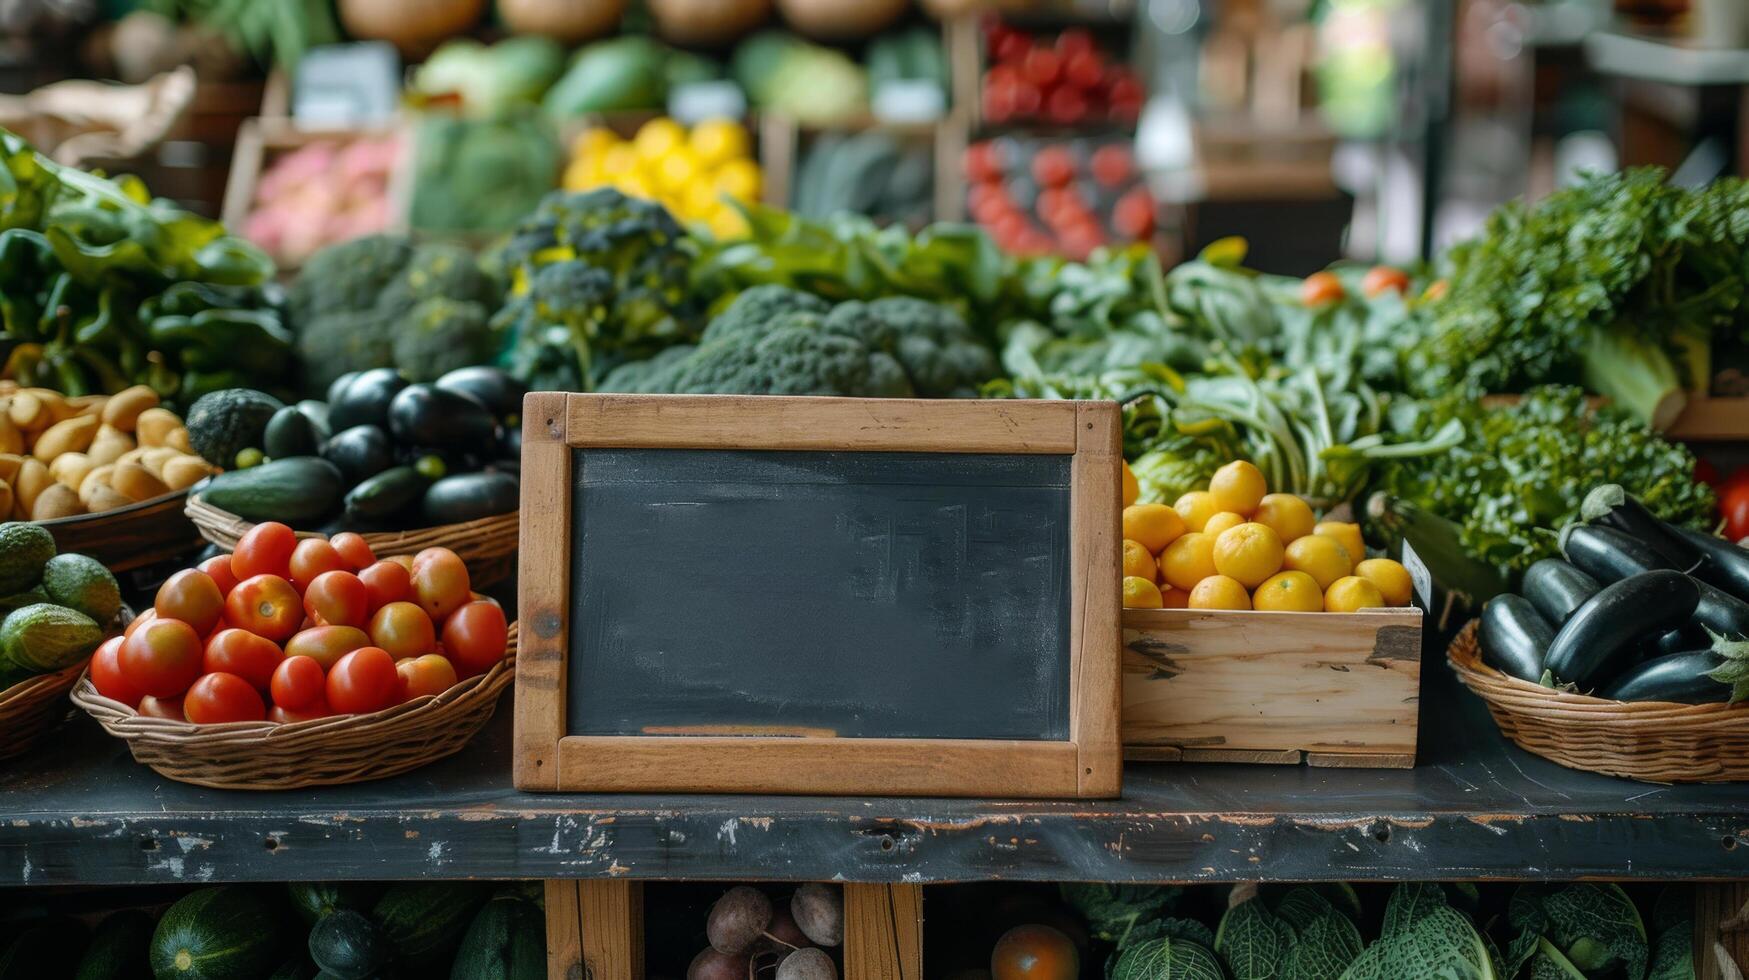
[512,392,572,791]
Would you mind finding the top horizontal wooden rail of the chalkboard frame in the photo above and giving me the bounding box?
[563,394,1076,453]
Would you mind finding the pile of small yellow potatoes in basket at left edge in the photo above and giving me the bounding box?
[0,382,213,520]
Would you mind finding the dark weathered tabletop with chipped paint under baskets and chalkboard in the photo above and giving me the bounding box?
[0,637,1749,884]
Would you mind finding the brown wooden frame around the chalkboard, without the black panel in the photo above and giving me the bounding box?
[512,392,1123,798]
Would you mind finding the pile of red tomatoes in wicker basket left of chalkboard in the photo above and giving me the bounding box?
[91,523,509,725]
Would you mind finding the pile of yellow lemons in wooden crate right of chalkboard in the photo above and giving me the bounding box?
[1123,460,1411,613]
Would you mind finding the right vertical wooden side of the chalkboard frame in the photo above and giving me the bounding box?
[1069,403,1123,796]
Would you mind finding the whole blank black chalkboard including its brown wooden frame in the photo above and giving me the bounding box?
[514,392,1121,796]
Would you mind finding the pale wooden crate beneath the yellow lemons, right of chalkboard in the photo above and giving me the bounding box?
[1123,609,1422,768]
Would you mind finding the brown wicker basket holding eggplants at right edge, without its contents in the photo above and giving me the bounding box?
[1446,620,1749,782]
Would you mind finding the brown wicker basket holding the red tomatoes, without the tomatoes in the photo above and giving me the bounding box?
[73,623,516,789]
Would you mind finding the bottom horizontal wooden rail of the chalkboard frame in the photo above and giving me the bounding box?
[556,735,1079,796]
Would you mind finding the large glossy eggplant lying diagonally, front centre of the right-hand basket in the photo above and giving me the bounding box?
[1544,567,1700,691]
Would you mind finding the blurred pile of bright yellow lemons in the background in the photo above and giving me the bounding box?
[563,116,764,238]
